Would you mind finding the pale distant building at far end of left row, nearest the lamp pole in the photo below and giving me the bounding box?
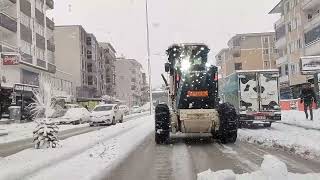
[115,58,143,107]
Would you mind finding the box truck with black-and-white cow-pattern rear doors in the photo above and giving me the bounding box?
[220,69,281,127]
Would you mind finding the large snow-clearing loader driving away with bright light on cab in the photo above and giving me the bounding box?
[155,44,239,144]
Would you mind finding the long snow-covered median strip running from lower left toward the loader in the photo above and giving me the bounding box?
[0,116,153,180]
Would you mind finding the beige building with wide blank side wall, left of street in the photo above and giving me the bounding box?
[54,25,97,98]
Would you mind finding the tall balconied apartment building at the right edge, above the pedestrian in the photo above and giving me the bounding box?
[269,0,320,99]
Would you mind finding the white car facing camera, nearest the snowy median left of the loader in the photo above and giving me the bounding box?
[90,104,124,126]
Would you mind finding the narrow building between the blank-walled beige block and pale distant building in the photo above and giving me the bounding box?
[99,42,116,97]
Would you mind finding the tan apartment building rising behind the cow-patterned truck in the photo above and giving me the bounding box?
[215,32,278,78]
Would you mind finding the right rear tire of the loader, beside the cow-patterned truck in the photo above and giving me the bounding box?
[218,103,239,144]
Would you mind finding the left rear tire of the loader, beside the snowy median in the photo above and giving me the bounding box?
[155,104,170,144]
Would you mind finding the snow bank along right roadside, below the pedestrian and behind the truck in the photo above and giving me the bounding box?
[238,124,320,159]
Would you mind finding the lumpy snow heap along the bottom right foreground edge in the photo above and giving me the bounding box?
[197,155,320,180]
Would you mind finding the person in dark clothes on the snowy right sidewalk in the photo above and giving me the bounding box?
[300,83,316,120]
